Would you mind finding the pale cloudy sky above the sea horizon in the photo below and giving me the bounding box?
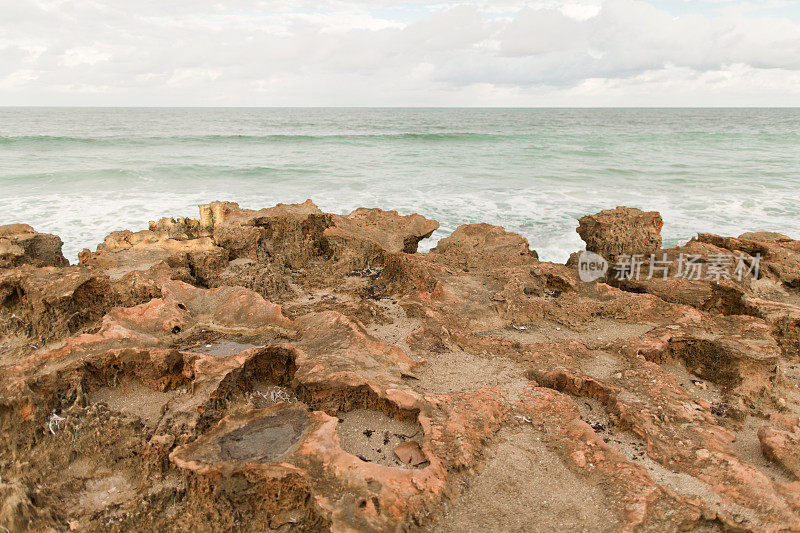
[0,0,800,106]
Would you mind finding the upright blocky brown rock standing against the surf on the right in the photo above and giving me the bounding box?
[577,207,664,260]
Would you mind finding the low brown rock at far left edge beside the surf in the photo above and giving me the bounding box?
[0,224,69,268]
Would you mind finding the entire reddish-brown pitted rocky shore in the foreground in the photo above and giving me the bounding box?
[0,201,800,532]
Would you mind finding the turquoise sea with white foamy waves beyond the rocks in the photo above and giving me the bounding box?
[0,108,800,261]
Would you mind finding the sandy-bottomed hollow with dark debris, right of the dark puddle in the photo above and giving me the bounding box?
[336,409,428,468]
